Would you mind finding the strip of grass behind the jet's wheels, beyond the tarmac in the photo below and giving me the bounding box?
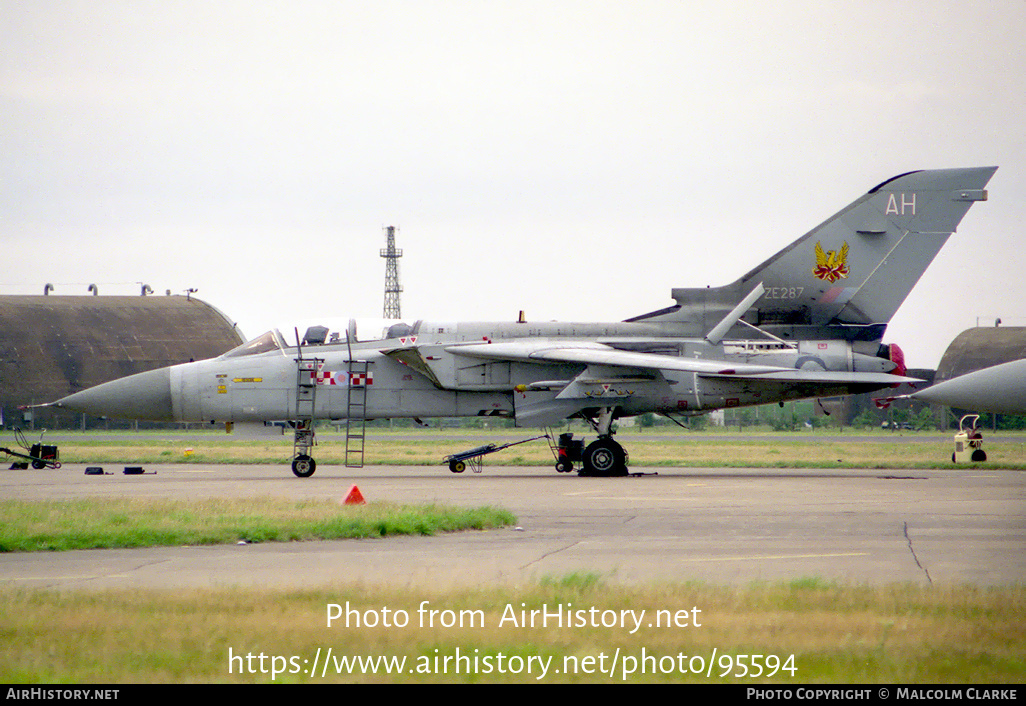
[26,427,1026,470]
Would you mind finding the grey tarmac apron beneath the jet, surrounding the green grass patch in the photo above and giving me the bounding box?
[0,464,1026,590]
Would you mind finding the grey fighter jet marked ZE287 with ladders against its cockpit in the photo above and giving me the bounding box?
[54,167,996,477]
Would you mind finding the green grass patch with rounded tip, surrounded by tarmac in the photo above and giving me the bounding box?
[0,498,516,552]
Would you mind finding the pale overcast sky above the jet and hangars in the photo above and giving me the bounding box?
[0,0,1026,367]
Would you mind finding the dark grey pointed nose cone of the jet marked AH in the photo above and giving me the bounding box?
[54,367,174,422]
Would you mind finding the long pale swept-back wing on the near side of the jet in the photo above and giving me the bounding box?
[445,341,916,385]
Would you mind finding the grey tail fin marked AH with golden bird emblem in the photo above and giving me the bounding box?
[629,167,997,341]
